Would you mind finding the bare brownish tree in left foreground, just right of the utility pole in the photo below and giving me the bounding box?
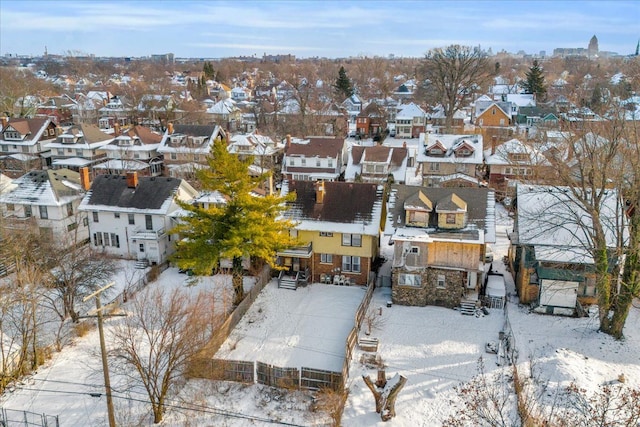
[113,288,222,423]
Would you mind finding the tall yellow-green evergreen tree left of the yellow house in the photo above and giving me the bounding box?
[172,140,296,304]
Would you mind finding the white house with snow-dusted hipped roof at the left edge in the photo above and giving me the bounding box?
[0,169,89,248]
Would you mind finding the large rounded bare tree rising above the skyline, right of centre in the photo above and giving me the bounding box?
[422,45,491,132]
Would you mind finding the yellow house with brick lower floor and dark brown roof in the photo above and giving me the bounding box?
[278,181,383,285]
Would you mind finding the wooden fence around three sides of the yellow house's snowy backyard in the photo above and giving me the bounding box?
[188,268,376,390]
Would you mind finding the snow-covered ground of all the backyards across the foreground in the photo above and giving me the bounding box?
[0,208,640,427]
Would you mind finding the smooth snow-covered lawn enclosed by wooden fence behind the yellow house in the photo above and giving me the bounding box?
[216,280,365,372]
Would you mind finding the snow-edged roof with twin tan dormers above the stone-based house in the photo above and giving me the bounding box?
[385,185,496,243]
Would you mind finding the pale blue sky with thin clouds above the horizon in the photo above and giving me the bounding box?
[0,0,640,58]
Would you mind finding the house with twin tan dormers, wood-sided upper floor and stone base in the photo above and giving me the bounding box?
[385,185,495,308]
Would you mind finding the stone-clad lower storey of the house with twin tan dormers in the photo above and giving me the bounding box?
[391,268,467,308]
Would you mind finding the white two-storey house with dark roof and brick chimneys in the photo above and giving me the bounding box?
[80,172,198,264]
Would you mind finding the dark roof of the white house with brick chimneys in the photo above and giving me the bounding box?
[81,175,182,211]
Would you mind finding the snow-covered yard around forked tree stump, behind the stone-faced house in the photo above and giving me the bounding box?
[342,288,503,427]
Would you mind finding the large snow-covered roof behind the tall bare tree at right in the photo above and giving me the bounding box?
[514,184,623,263]
